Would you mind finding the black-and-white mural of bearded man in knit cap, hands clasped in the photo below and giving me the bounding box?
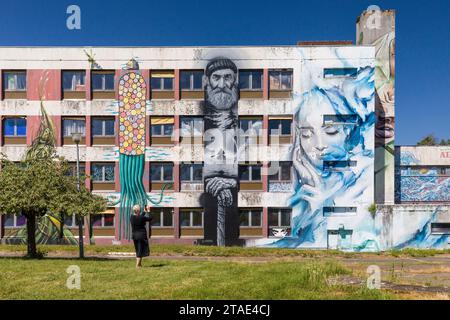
[202,58,239,246]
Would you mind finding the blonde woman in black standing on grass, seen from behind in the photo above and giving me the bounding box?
[130,204,152,268]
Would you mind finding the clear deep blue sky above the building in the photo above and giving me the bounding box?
[0,0,450,145]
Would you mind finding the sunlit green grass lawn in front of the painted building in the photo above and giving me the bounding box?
[0,258,395,299]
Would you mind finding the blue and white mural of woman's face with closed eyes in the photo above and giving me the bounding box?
[255,49,381,251]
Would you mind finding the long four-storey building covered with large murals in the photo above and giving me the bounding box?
[0,6,450,250]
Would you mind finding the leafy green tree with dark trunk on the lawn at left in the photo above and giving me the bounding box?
[0,157,106,258]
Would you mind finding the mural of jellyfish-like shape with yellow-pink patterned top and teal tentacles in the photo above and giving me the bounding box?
[117,59,166,240]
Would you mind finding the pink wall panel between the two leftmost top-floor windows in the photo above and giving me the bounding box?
[27,69,61,100]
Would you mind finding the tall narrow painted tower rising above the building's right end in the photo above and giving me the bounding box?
[357,9,395,204]
